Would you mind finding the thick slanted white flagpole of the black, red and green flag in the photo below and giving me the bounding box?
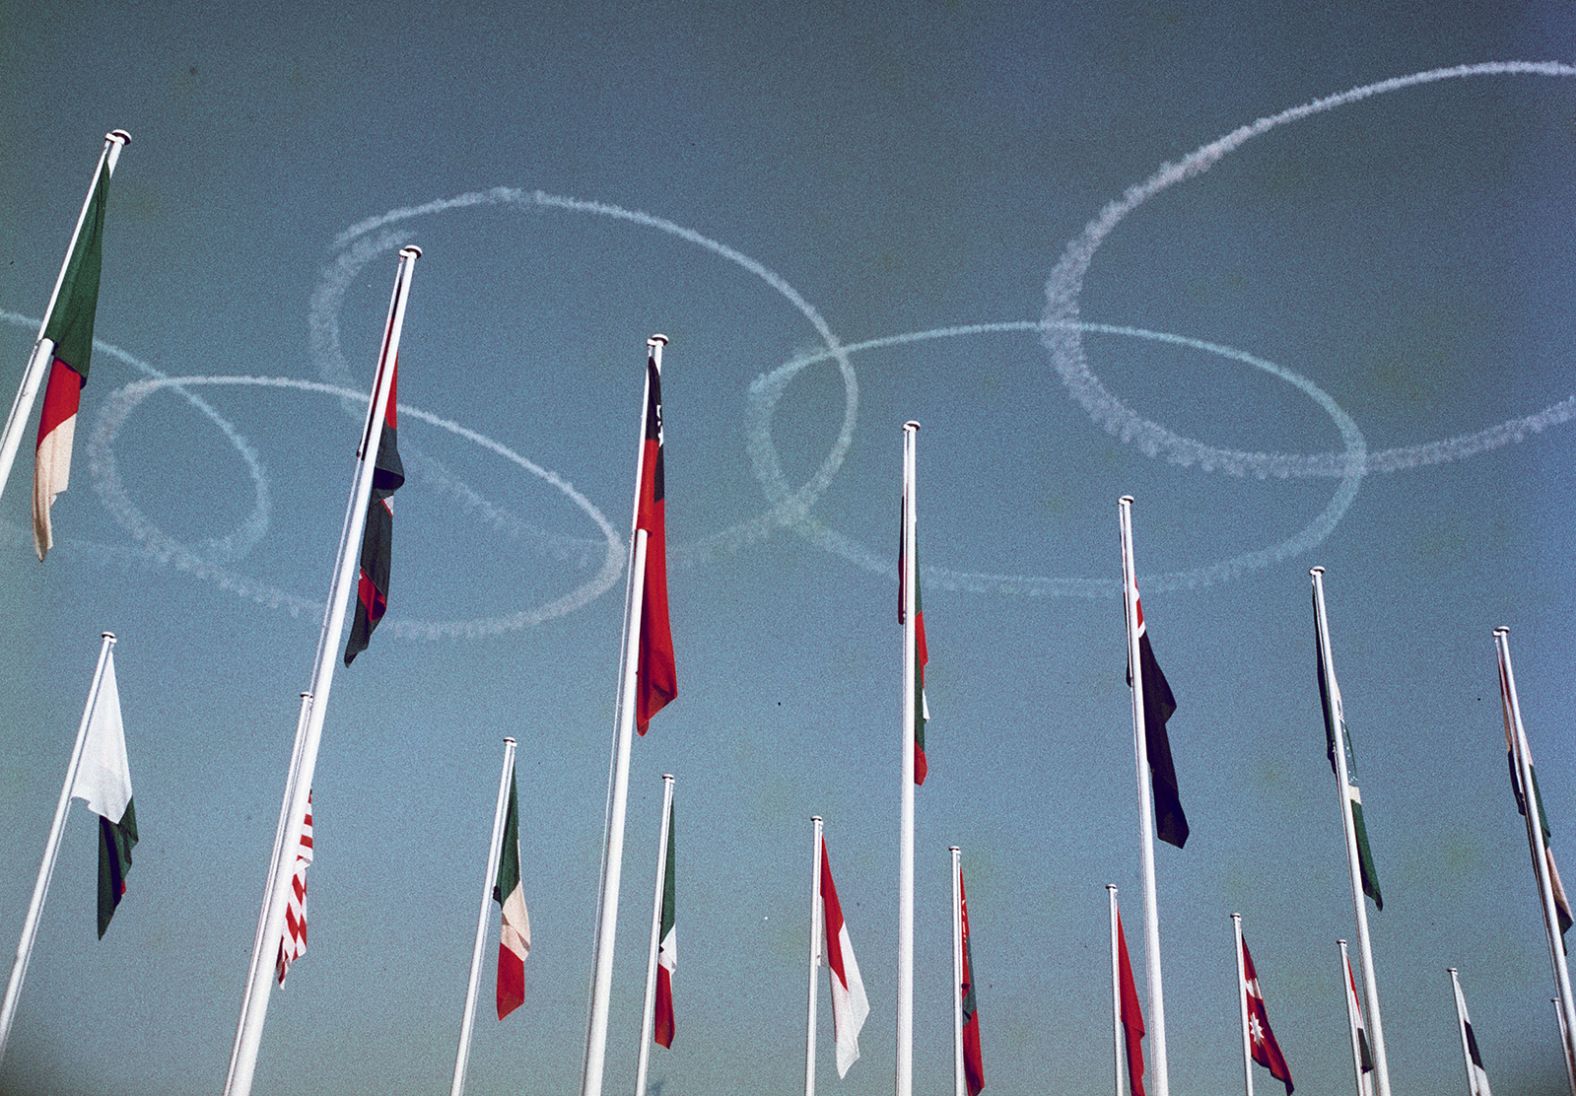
[224,246,421,1096]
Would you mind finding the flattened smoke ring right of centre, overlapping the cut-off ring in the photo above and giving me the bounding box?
[745,320,1368,598]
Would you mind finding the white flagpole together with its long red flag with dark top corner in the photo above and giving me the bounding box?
[580,334,678,1096]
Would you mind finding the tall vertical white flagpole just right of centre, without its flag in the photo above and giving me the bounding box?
[895,419,919,1096]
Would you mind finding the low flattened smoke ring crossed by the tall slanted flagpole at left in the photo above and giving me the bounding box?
[88,375,624,639]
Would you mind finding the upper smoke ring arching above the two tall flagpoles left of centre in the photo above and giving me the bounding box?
[307,186,859,566]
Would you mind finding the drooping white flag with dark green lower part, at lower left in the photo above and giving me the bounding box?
[71,646,137,938]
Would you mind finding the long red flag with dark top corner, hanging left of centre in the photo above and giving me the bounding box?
[635,356,679,735]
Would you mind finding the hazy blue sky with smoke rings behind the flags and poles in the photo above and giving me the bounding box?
[0,0,1576,1096]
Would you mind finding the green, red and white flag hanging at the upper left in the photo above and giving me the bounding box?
[33,159,109,560]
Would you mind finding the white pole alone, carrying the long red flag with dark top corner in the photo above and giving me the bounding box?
[580,334,668,1096]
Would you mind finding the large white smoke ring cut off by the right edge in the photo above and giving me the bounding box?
[1042,62,1576,478]
